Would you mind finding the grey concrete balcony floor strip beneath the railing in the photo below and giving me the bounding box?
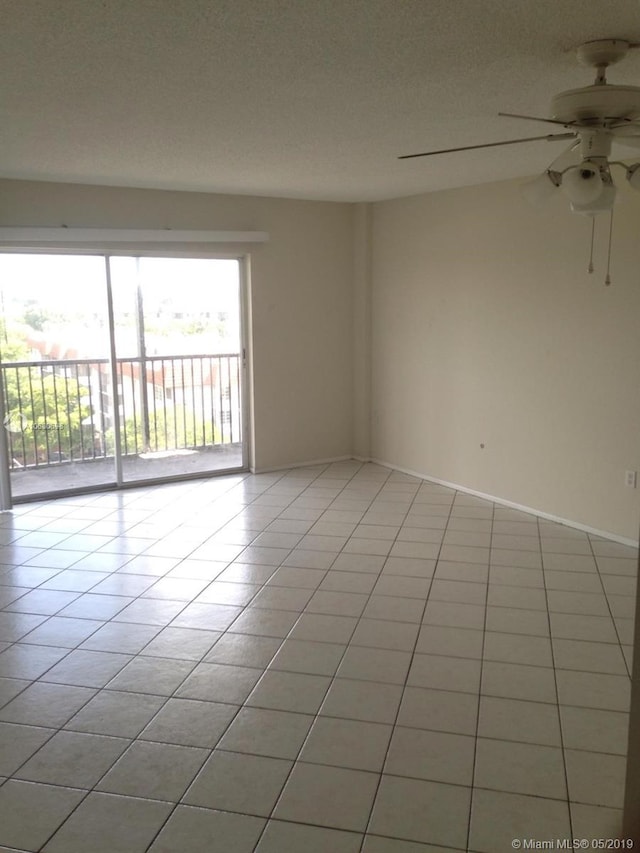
[11,444,242,499]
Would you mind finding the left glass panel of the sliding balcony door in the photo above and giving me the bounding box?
[0,254,115,498]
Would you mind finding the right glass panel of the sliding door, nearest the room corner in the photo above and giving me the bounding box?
[110,257,244,482]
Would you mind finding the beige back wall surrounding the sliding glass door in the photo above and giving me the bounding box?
[0,181,354,469]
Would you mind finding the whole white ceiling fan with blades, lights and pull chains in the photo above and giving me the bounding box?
[400,39,640,284]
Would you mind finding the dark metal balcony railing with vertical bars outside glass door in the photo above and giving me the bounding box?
[0,353,242,470]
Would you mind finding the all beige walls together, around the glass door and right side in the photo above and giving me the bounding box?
[0,175,640,539]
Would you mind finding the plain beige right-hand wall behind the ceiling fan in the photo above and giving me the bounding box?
[372,181,640,539]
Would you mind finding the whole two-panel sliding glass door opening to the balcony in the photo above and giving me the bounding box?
[0,254,245,498]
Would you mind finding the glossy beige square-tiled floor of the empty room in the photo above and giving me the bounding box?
[0,462,636,853]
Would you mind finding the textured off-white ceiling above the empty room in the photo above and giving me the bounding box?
[0,0,640,201]
